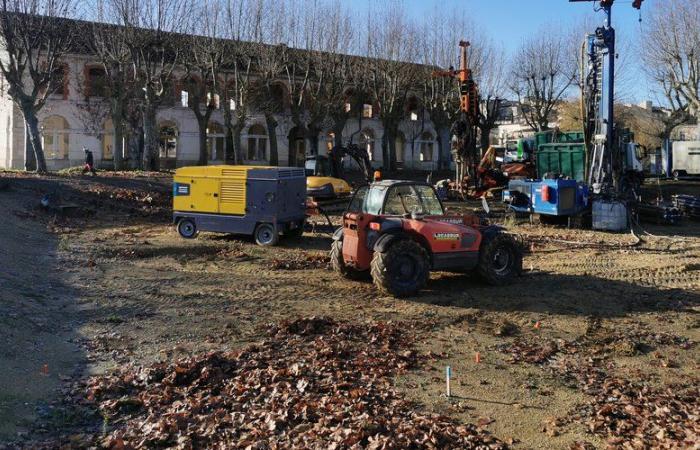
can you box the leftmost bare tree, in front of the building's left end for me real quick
[0,0,79,173]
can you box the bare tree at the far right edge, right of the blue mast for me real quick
[641,0,700,139]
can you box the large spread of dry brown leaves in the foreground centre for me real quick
[88,317,505,449]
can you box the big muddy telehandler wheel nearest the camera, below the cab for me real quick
[371,239,430,297]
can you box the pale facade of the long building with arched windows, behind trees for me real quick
[0,41,450,170]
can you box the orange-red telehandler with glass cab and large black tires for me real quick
[330,180,522,297]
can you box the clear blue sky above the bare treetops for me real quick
[360,0,656,103]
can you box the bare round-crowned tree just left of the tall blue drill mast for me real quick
[510,27,578,131]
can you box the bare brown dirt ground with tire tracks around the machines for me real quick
[0,173,700,449]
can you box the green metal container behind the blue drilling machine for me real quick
[536,143,586,181]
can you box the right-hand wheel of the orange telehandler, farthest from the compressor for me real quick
[477,233,523,286]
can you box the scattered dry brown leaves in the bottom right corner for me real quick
[498,329,700,449]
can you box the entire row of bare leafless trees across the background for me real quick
[0,0,700,171]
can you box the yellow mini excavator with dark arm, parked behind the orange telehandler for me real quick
[305,142,373,213]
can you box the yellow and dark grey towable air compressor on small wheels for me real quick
[173,166,306,245]
